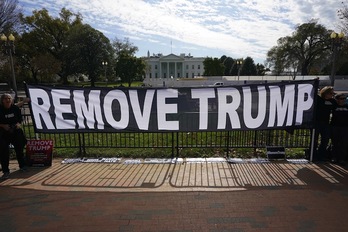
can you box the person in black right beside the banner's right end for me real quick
[314,86,337,161]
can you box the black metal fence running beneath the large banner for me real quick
[22,106,311,157]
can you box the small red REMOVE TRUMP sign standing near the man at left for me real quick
[26,140,53,167]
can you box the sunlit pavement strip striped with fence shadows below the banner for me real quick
[0,161,348,191]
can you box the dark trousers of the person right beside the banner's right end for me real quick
[313,123,331,161]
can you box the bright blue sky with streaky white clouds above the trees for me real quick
[18,0,343,64]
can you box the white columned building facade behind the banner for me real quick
[145,53,205,79]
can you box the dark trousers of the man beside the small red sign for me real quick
[0,129,27,173]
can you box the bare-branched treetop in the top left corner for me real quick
[0,0,21,34]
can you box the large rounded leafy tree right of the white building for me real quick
[267,20,330,75]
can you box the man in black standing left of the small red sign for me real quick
[0,93,26,179]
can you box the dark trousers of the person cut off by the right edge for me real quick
[332,126,348,162]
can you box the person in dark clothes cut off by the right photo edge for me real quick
[331,94,348,165]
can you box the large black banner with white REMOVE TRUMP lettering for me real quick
[27,80,318,132]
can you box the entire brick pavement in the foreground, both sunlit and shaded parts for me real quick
[0,159,348,232]
